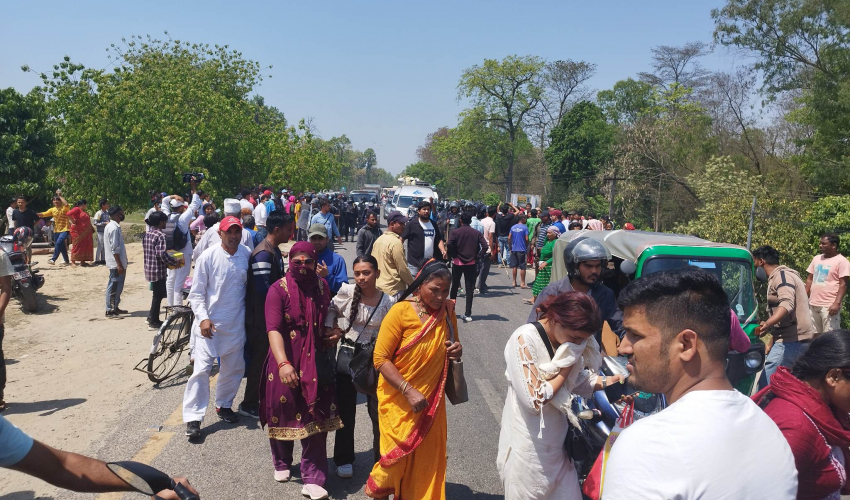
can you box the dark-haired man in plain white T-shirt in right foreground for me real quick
[602,269,797,500]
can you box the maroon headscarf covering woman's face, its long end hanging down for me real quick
[284,241,330,414]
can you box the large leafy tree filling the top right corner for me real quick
[712,0,850,192]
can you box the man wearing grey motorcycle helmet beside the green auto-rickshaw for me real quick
[528,237,625,345]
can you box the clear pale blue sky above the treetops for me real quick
[0,0,736,173]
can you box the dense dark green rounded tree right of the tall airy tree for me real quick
[545,101,614,195]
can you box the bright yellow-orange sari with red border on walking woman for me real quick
[366,301,457,500]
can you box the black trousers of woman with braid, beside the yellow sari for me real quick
[334,374,381,467]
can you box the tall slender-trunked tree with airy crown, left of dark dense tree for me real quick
[458,56,545,197]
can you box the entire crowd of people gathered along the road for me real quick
[0,178,850,500]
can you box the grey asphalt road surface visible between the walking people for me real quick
[58,234,531,500]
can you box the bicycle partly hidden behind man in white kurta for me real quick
[135,306,195,384]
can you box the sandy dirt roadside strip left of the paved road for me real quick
[0,243,162,500]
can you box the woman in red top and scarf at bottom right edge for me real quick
[753,330,850,500]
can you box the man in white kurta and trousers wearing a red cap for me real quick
[183,216,251,439]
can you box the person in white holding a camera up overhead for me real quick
[165,175,201,306]
